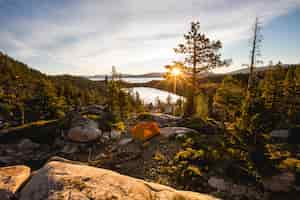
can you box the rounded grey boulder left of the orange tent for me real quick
[67,119,102,142]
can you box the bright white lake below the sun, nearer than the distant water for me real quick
[130,87,182,104]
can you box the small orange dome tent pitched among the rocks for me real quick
[131,122,160,141]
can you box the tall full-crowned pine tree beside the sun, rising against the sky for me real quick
[174,22,224,115]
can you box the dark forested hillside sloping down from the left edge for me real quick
[0,52,104,126]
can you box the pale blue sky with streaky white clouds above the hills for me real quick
[0,0,300,75]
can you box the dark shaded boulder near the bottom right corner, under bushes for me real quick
[262,172,296,192]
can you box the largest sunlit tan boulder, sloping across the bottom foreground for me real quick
[19,161,216,200]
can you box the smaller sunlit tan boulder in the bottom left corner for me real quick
[0,165,30,200]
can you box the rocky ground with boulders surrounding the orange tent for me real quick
[0,106,297,200]
